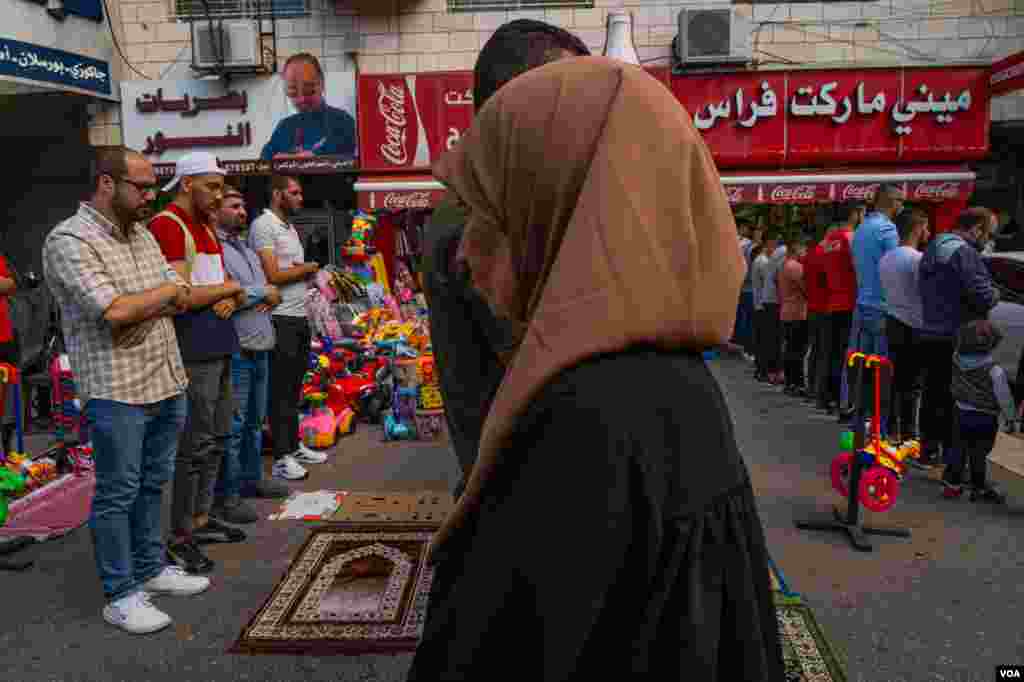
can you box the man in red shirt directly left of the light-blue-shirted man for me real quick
[818,202,867,414]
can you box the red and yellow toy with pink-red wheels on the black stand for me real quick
[831,353,921,512]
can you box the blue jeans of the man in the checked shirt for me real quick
[85,395,187,601]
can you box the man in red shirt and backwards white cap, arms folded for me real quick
[150,152,245,573]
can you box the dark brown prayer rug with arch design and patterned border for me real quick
[228,524,437,655]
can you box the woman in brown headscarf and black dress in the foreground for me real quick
[409,57,783,682]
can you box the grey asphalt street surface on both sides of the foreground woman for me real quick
[0,356,1024,682]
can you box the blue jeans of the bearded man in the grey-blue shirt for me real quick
[215,350,270,502]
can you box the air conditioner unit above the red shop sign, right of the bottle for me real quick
[673,7,753,65]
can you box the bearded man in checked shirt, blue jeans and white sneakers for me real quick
[43,147,210,633]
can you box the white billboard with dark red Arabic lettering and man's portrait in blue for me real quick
[121,73,356,169]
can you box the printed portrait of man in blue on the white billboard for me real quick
[260,52,356,161]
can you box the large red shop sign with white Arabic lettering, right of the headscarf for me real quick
[670,68,989,167]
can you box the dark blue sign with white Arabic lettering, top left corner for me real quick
[0,38,111,95]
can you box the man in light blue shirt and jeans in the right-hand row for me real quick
[840,184,903,421]
